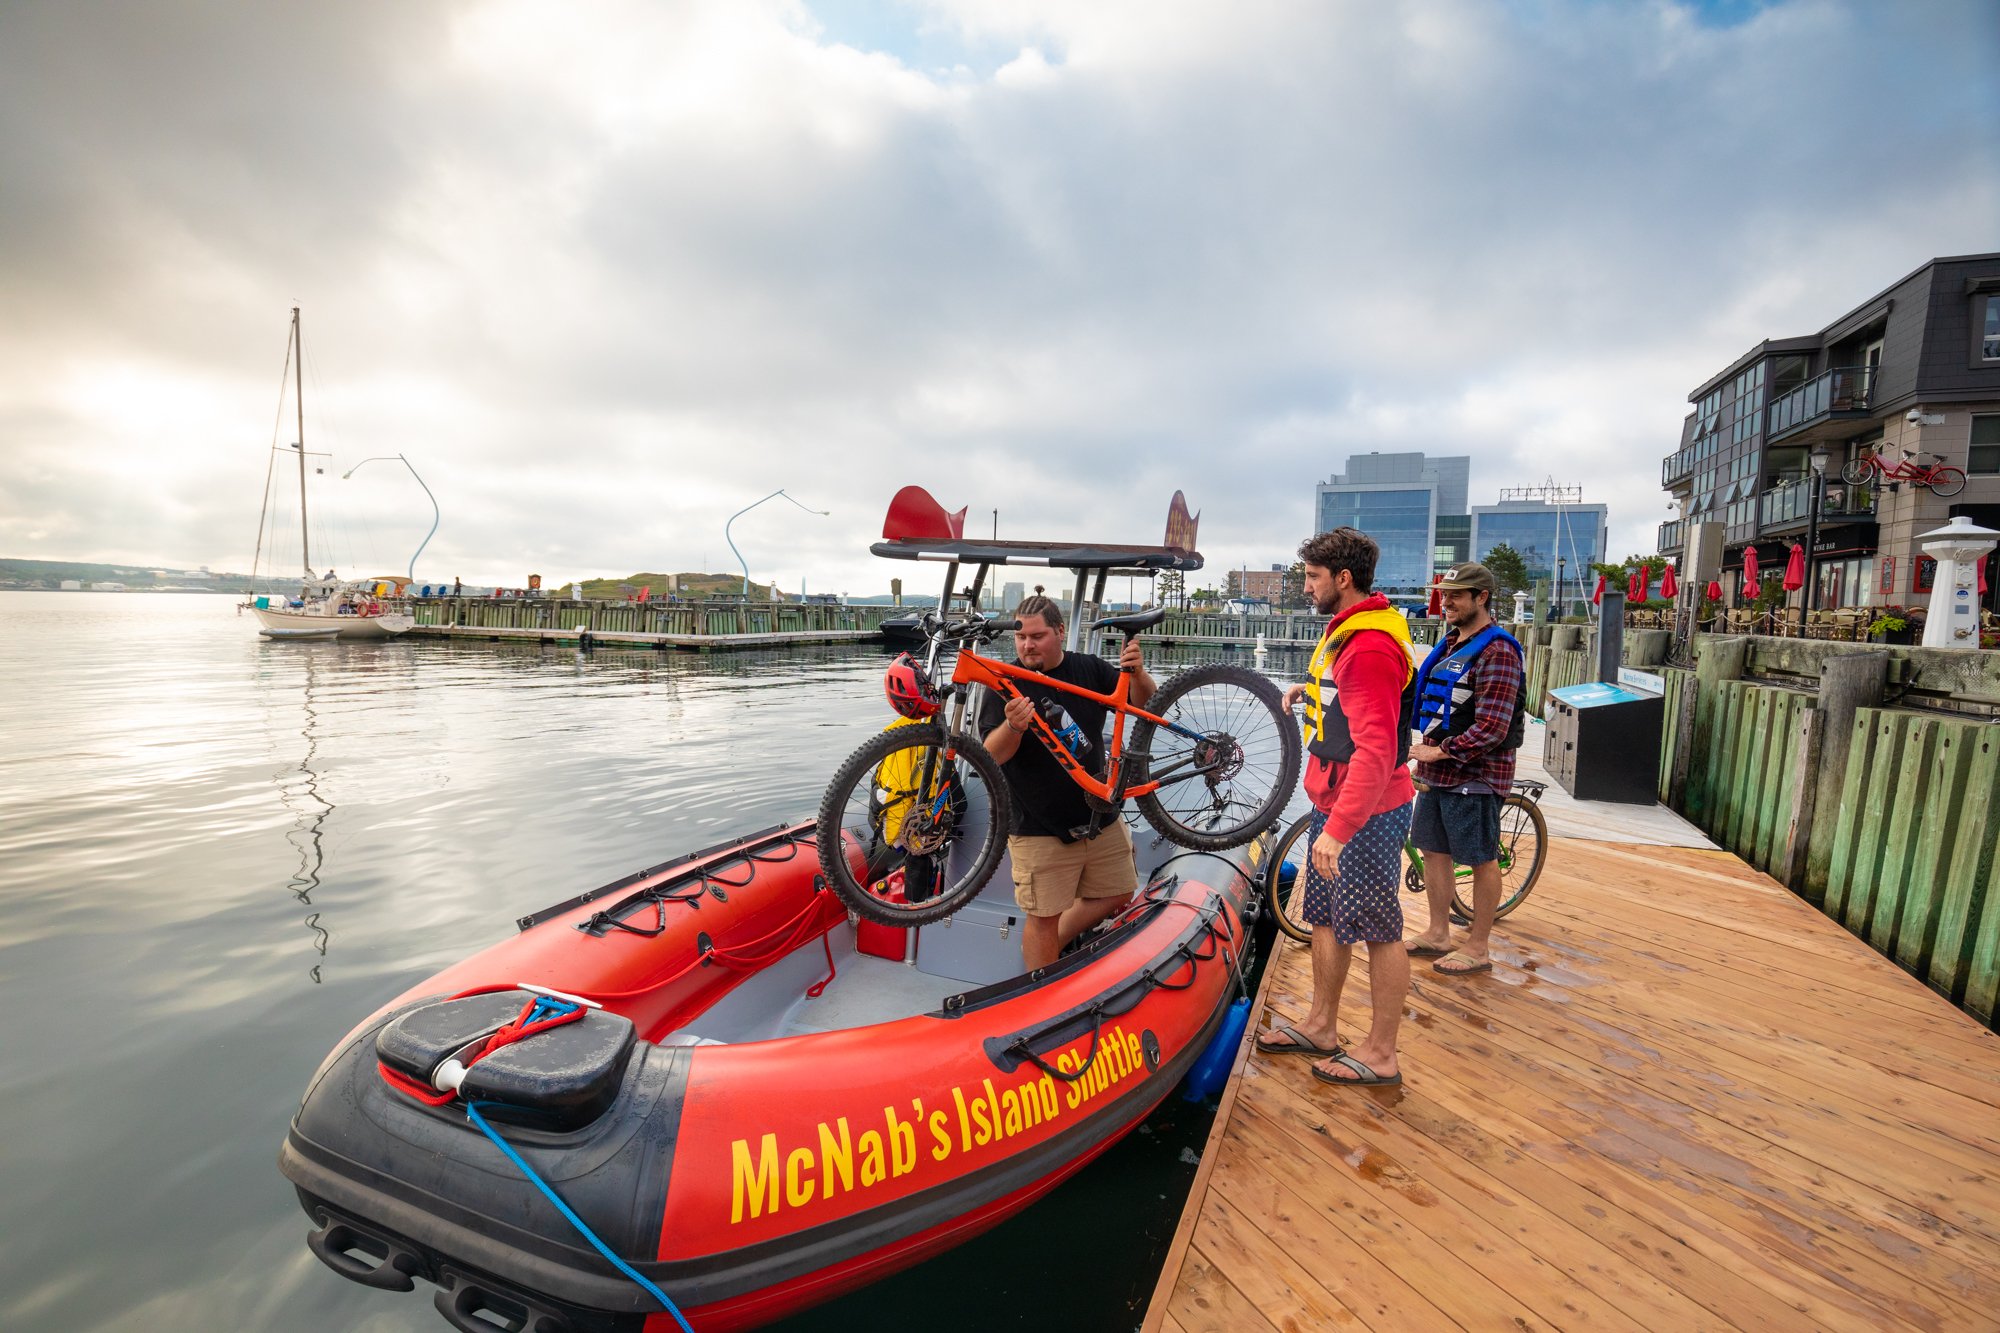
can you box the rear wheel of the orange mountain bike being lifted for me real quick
[1128,662,1300,851]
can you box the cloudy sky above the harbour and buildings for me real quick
[0,0,2000,594]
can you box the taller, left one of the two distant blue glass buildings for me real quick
[1314,452,1472,600]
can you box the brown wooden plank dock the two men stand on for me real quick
[1144,836,2000,1333]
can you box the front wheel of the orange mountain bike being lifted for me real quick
[818,723,1012,927]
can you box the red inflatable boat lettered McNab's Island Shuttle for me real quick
[280,825,1264,1333]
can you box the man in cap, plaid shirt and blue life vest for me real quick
[1408,564,1526,977]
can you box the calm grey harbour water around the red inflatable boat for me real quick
[0,592,1248,1333]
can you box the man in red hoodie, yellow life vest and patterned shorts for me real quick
[1256,528,1416,1087]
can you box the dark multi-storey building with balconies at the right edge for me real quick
[1658,252,2000,608]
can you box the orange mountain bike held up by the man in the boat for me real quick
[818,610,1300,925]
